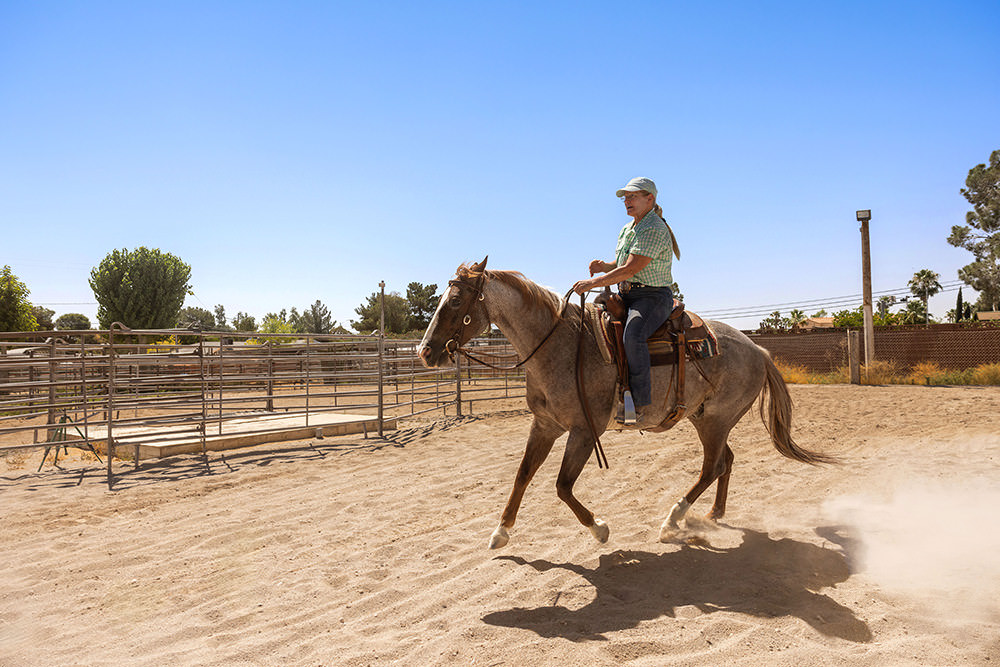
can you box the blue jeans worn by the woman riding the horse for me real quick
[622,287,674,408]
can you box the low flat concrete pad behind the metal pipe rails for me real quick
[88,413,396,459]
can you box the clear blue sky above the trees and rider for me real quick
[0,0,1000,328]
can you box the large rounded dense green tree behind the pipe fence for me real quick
[90,247,191,329]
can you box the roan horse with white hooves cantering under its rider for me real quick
[417,257,835,549]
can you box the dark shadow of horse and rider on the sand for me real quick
[483,527,872,642]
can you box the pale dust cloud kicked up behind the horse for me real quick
[824,470,1000,620]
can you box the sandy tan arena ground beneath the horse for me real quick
[0,386,1000,667]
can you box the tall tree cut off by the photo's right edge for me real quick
[948,150,1000,310]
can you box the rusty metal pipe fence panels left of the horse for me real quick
[0,327,525,488]
